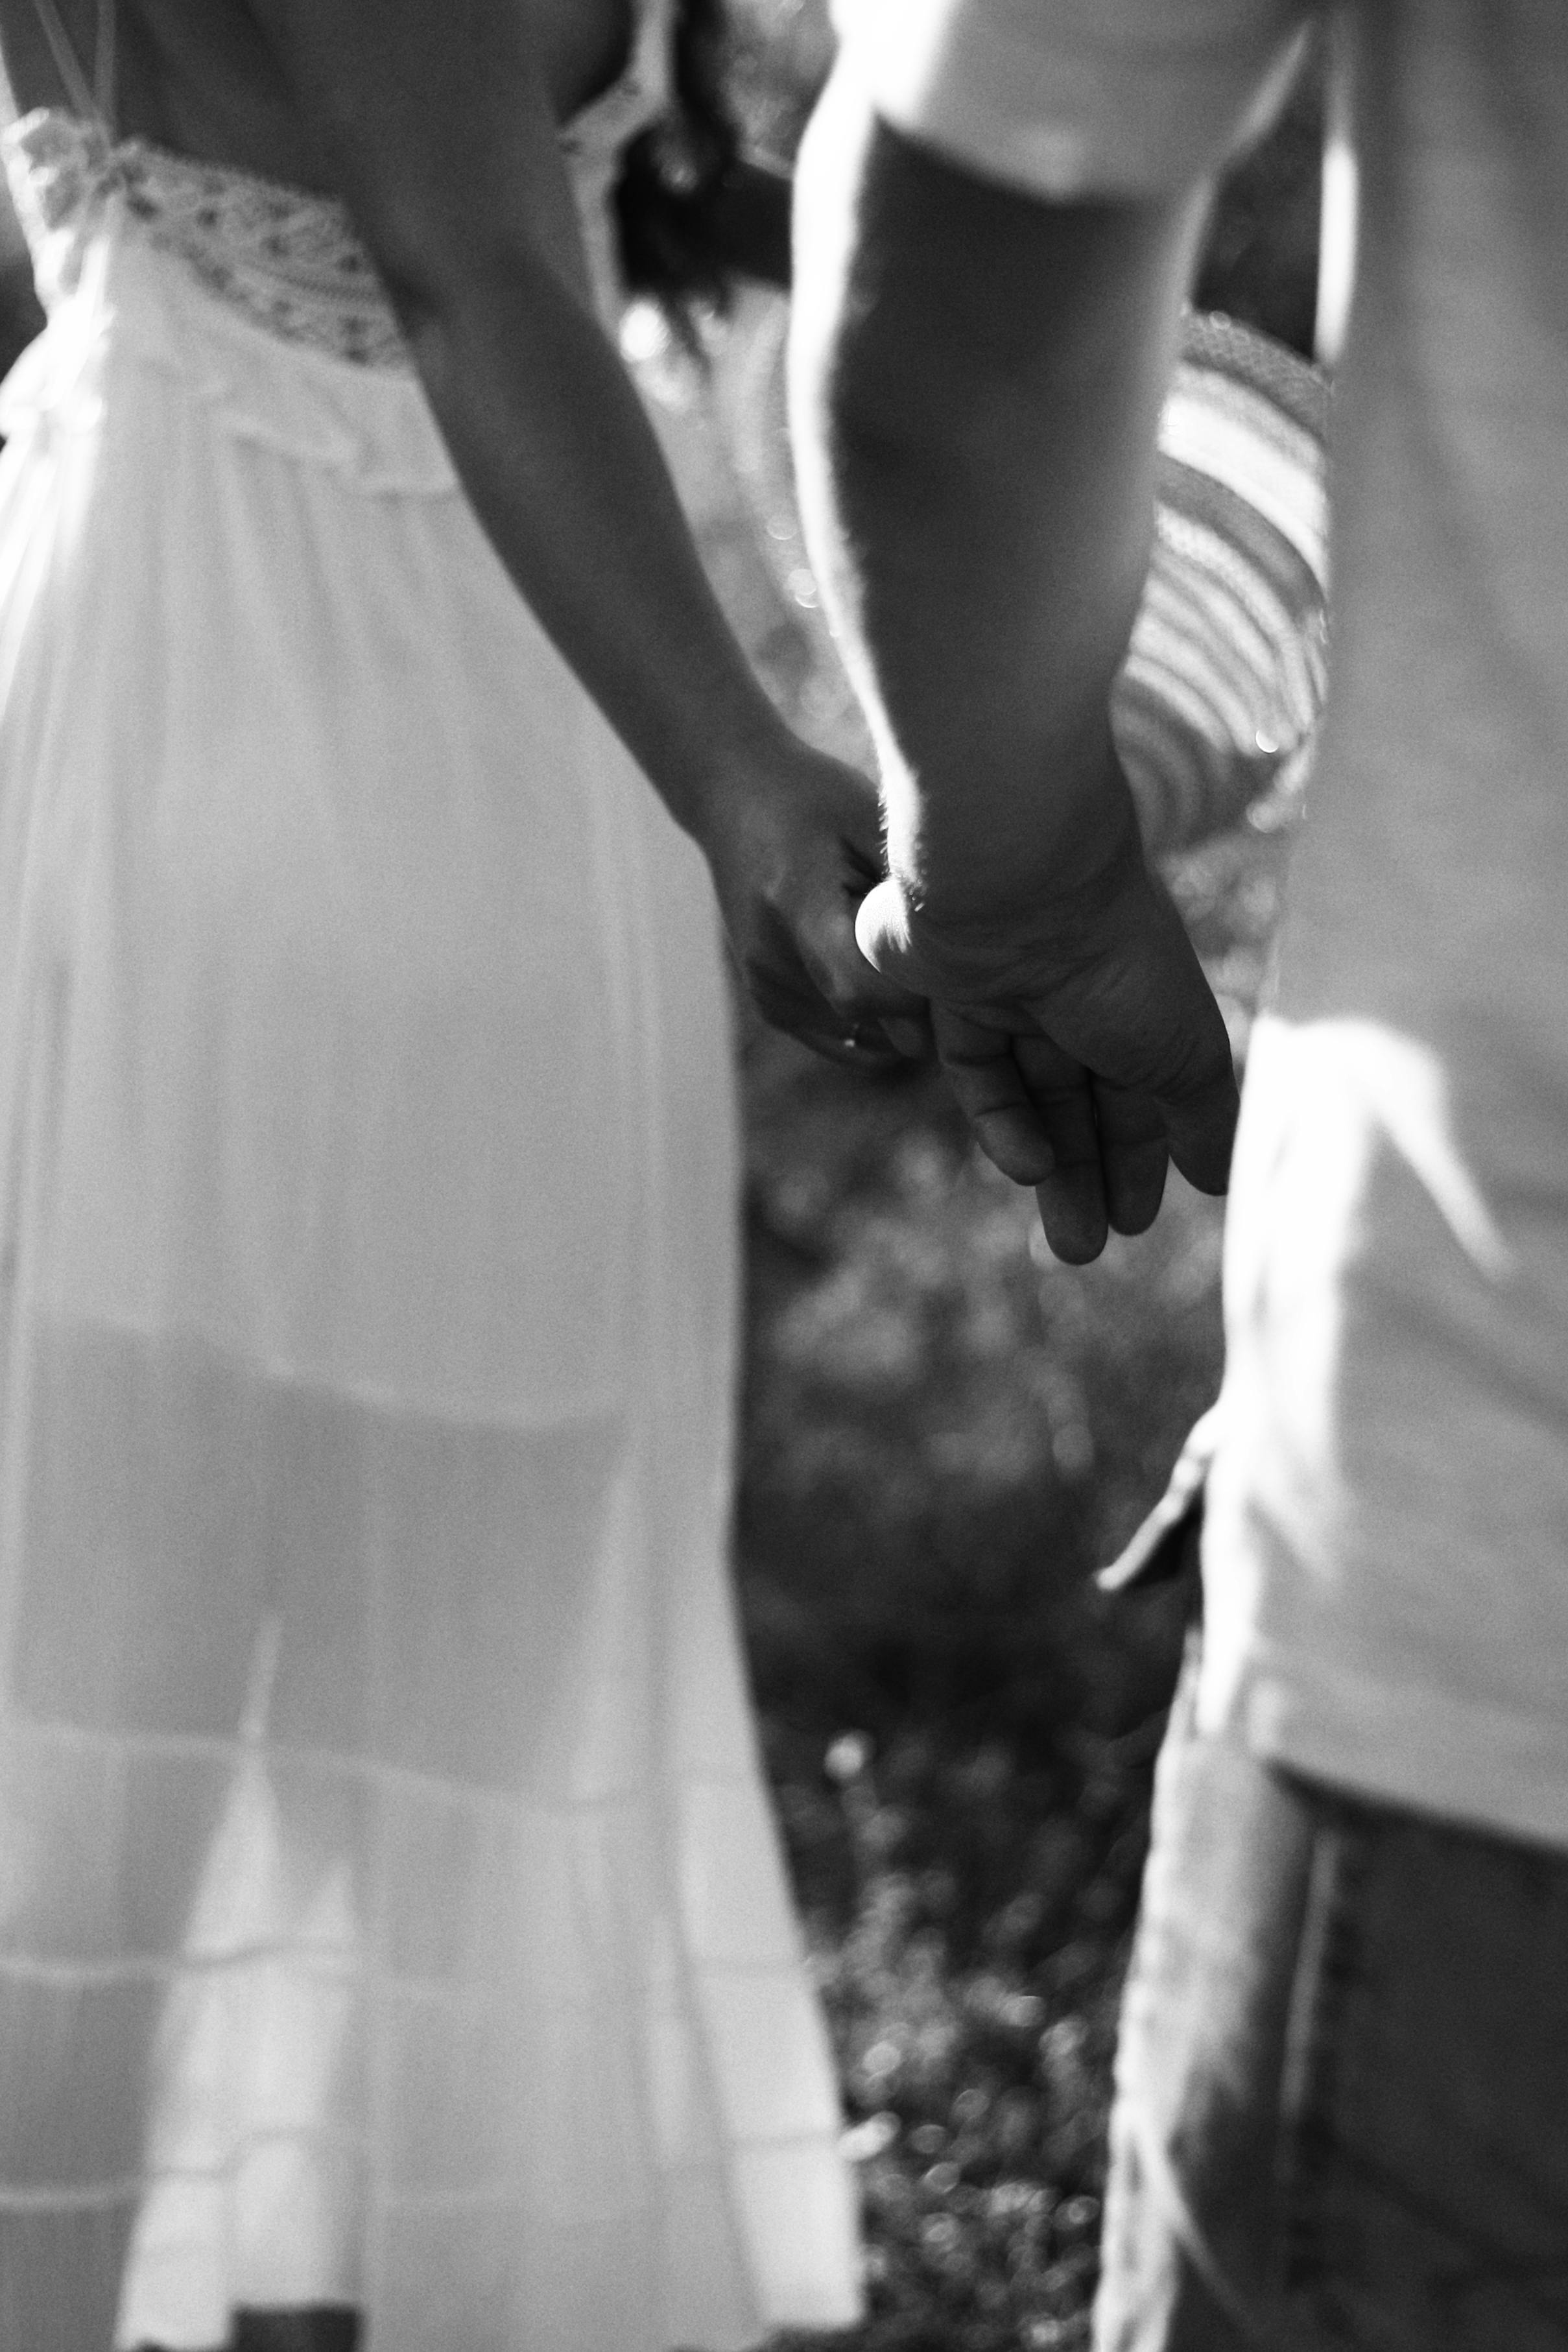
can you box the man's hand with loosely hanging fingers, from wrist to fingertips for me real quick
[858,800,1237,1265]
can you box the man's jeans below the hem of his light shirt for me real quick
[1095,1677,1568,2352]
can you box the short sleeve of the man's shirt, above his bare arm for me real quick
[835,0,1319,198]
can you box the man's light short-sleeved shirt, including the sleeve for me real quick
[839,0,1568,1846]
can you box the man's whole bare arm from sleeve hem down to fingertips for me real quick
[792,68,1237,1258]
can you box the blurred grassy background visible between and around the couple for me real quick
[731,0,1319,2352]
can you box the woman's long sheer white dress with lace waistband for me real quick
[0,5,858,2352]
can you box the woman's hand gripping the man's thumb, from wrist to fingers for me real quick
[693,743,931,1068]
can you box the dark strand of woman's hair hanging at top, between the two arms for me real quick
[616,0,741,339]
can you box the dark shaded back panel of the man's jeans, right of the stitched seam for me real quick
[1276,1800,1568,2352]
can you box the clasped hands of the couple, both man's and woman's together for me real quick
[703,746,1237,1265]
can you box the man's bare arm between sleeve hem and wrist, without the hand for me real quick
[792,64,1201,918]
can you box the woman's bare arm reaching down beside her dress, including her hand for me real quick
[254,0,914,1044]
